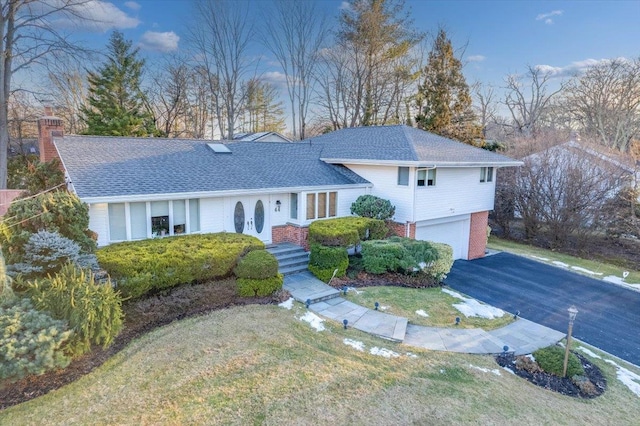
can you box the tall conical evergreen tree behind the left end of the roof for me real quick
[82,31,158,136]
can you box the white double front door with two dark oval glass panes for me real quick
[232,197,271,243]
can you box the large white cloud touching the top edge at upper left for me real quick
[50,0,140,32]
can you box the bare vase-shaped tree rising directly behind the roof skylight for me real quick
[190,0,254,139]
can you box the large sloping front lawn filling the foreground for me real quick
[0,304,640,425]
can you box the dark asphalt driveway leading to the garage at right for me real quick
[445,253,640,365]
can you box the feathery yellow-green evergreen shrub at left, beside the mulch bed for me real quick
[27,263,123,355]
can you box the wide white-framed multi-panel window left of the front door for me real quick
[108,199,200,242]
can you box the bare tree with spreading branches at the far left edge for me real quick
[0,0,92,189]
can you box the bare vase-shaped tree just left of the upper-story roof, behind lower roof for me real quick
[263,0,327,139]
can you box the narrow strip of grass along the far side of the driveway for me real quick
[487,236,640,284]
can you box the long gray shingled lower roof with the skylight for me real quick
[55,136,369,198]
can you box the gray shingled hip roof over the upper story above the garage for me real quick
[309,125,522,167]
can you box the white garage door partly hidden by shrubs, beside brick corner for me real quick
[416,215,471,259]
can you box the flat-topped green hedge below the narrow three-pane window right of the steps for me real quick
[309,216,388,247]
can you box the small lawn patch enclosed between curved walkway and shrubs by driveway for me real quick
[346,287,513,330]
